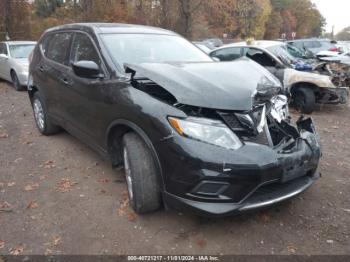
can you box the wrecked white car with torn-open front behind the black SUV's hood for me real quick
[210,41,350,114]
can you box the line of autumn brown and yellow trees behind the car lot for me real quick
[0,0,325,40]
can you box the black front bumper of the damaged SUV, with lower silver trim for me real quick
[158,119,321,216]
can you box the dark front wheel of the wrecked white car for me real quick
[292,87,316,114]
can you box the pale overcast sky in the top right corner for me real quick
[311,0,350,33]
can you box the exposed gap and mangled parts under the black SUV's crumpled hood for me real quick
[131,74,312,150]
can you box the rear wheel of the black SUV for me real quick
[32,92,60,136]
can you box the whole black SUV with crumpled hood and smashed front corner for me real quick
[28,24,321,216]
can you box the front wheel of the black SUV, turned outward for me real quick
[122,133,161,214]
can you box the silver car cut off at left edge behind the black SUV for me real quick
[0,41,36,91]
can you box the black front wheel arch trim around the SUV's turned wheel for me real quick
[106,119,164,188]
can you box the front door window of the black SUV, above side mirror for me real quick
[71,33,101,65]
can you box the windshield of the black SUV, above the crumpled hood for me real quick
[101,34,213,69]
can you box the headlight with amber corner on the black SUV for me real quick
[168,117,242,149]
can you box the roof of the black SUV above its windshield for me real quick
[46,23,177,35]
